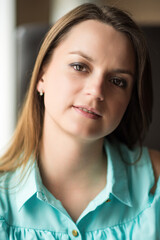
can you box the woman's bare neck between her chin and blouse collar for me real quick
[39,116,106,195]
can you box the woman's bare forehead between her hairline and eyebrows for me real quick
[59,20,132,54]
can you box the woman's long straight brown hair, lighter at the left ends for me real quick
[0,4,152,172]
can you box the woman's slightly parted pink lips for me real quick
[73,106,102,120]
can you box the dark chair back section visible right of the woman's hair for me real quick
[142,26,160,150]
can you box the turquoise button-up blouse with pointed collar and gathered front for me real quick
[0,141,160,240]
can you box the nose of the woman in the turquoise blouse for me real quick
[85,76,104,101]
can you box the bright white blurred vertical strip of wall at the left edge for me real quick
[0,0,16,154]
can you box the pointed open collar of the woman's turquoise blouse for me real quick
[16,140,132,211]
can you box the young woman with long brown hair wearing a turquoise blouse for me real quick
[0,4,160,240]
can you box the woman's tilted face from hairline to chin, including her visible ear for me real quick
[37,20,135,141]
